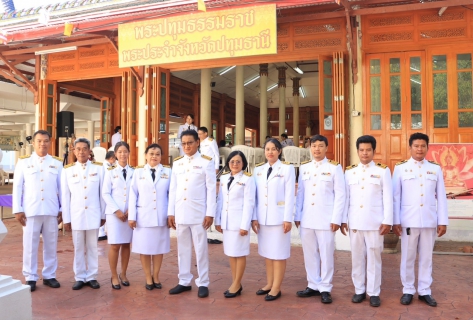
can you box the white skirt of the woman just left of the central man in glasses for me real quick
[131,227,171,255]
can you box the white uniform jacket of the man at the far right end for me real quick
[393,158,448,228]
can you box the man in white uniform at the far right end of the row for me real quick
[393,133,448,307]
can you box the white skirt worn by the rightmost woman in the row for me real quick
[258,224,291,260]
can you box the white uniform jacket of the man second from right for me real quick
[343,161,393,230]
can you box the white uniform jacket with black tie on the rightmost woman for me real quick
[253,160,295,226]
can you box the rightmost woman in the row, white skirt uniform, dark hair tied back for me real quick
[252,138,296,301]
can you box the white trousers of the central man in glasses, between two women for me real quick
[176,224,210,287]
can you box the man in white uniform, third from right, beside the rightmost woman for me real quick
[294,135,345,303]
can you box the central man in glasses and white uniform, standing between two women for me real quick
[168,130,216,298]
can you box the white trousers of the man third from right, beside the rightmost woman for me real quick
[300,227,335,292]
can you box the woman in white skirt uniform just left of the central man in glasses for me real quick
[128,143,171,290]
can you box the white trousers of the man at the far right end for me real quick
[401,228,437,296]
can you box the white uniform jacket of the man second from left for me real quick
[61,161,105,230]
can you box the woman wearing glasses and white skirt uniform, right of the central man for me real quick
[215,151,256,298]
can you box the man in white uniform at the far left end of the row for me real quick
[13,130,62,292]
